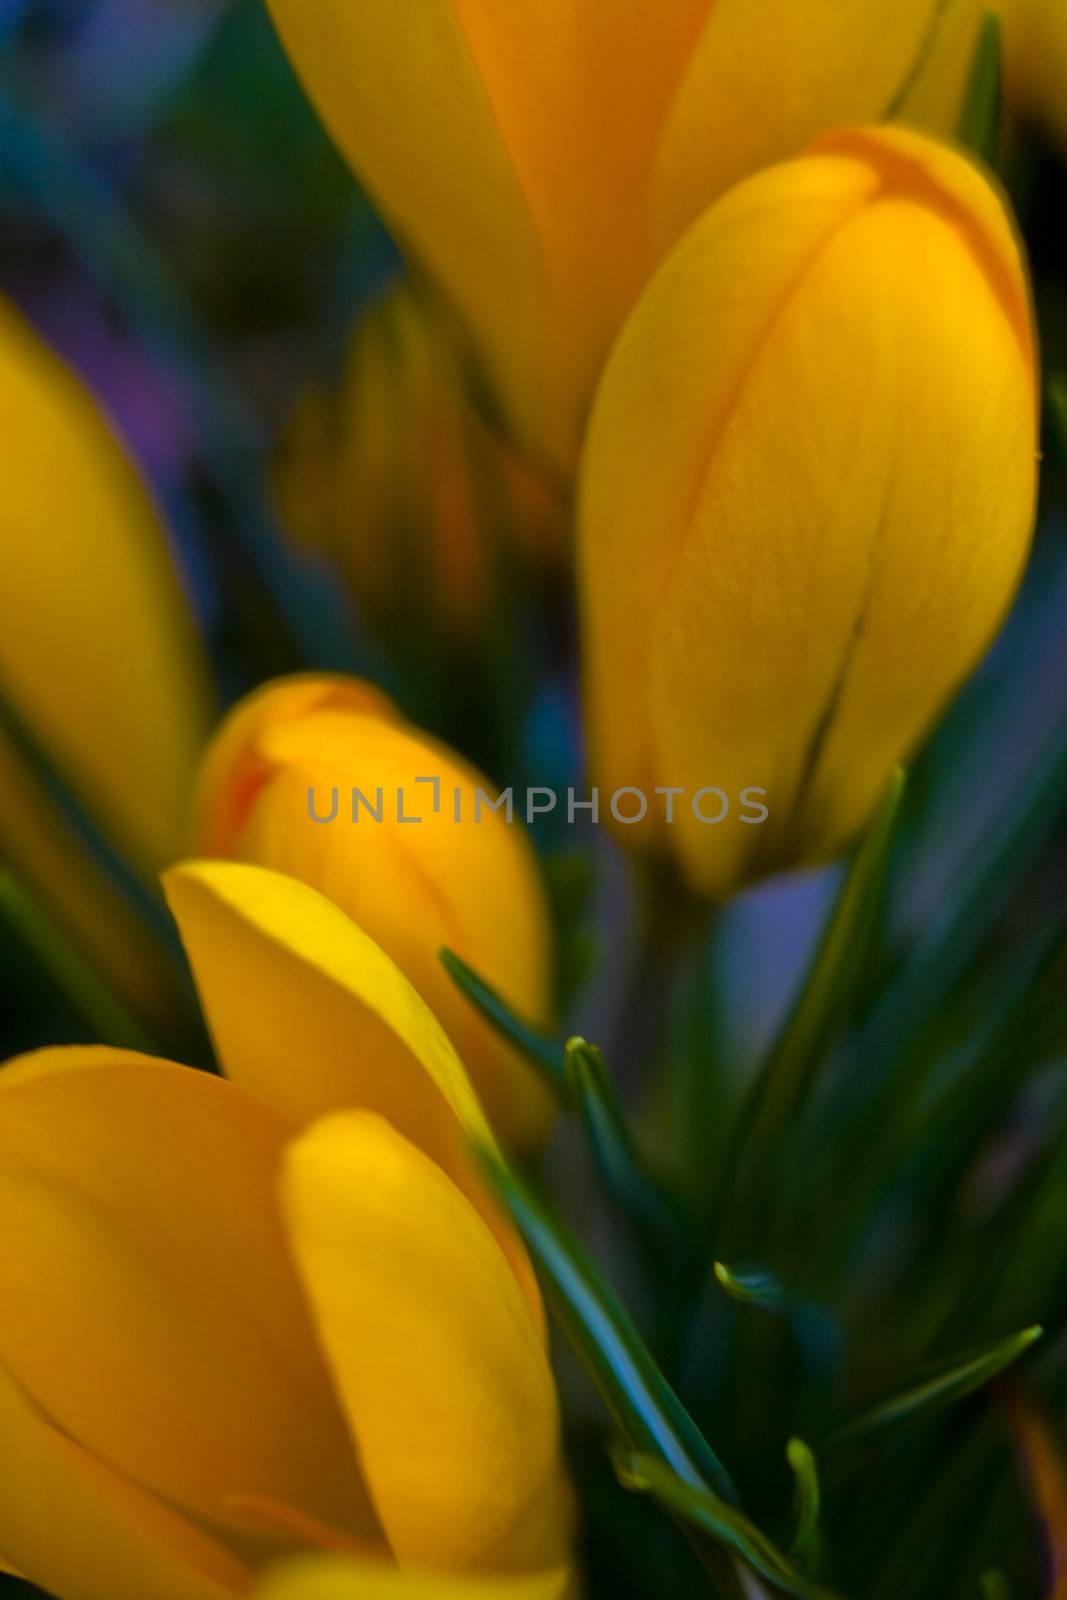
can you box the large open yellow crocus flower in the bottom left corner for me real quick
[0,862,568,1600]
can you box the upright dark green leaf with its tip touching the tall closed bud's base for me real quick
[720,768,904,1246]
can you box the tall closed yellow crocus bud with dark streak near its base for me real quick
[579,128,1037,896]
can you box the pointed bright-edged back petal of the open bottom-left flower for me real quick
[165,862,541,1307]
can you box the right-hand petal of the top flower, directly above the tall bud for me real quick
[649,0,979,254]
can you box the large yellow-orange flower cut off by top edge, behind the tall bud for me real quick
[267,0,979,469]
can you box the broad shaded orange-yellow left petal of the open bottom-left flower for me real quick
[0,1050,373,1542]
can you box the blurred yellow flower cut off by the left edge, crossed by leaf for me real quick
[0,299,210,987]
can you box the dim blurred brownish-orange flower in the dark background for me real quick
[275,282,563,642]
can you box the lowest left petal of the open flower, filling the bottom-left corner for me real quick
[0,1347,248,1600]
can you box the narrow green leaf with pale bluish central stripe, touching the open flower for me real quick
[475,1149,736,1501]
